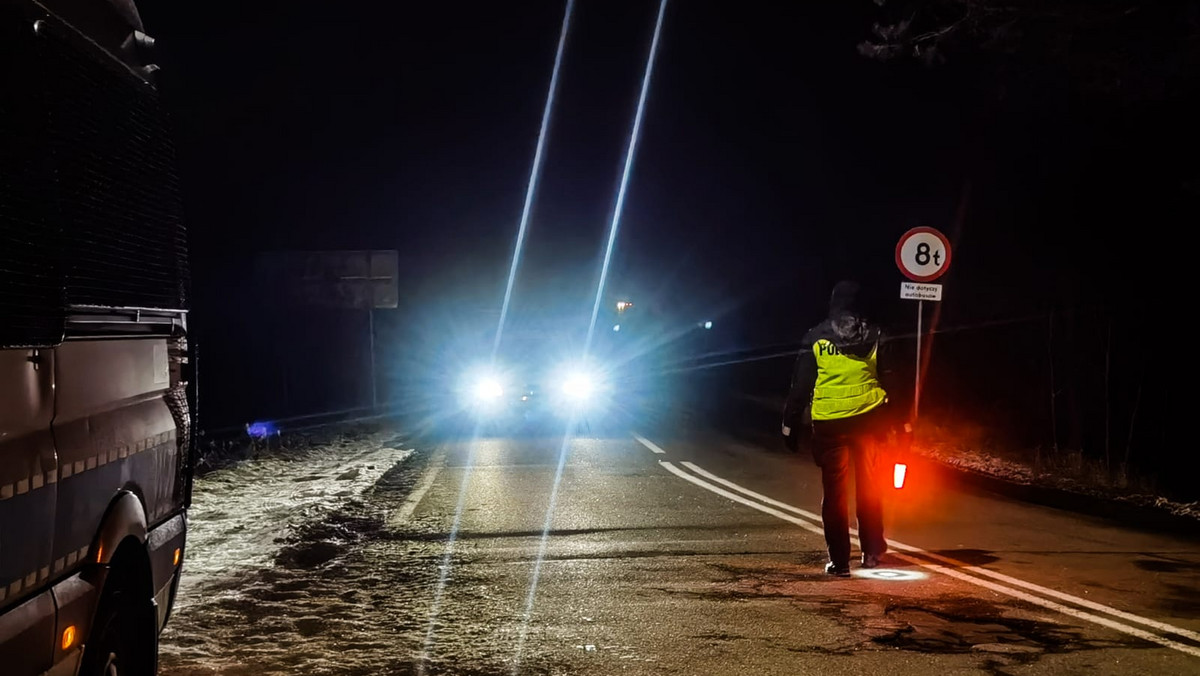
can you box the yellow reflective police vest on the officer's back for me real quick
[812,339,888,420]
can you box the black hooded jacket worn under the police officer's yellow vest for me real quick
[784,282,895,436]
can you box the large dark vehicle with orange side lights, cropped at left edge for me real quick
[0,0,194,676]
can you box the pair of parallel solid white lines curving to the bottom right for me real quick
[659,451,1200,657]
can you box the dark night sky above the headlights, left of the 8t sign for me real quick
[143,1,984,333]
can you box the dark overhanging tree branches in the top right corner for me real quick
[858,0,1200,102]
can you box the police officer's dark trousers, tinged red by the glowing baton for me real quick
[812,409,888,566]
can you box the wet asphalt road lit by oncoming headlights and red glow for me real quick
[162,421,1200,676]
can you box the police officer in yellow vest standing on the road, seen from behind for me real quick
[784,281,892,576]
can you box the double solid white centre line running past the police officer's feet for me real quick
[652,437,1200,657]
